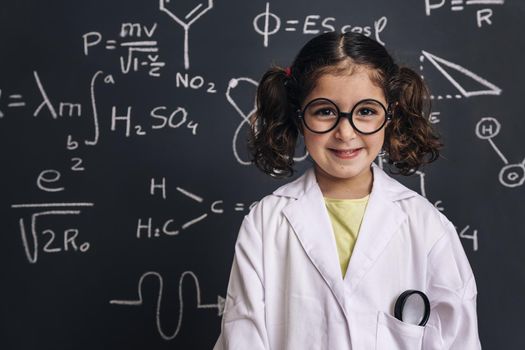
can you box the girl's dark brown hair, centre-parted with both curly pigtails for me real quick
[248,32,443,177]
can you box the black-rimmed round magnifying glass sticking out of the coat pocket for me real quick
[394,289,430,326]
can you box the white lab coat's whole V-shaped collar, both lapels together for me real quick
[274,163,416,319]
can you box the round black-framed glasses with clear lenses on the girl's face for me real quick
[297,97,392,135]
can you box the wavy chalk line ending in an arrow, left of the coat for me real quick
[109,271,225,340]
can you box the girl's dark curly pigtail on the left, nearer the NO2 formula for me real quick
[248,67,299,178]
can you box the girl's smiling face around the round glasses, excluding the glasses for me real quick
[301,67,387,189]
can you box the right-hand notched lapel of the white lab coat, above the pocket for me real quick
[345,163,415,296]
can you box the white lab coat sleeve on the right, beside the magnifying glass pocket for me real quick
[423,214,481,350]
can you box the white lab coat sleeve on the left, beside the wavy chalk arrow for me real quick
[214,213,269,350]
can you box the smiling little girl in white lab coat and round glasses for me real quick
[215,32,481,350]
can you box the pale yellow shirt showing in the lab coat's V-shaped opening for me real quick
[324,195,370,277]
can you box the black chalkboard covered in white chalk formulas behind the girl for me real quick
[0,0,525,350]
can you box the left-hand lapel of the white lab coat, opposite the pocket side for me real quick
[284,169,345,311]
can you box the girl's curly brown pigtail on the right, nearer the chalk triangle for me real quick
[384,67,443,175]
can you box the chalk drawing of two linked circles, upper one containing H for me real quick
[476,117,525,188]
